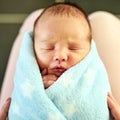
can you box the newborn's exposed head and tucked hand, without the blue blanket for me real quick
[34,4,91,88]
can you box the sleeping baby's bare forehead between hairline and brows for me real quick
[34,16,89,38]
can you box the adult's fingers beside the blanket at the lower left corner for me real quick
[0,98,11,120]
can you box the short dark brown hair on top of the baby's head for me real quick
[34,3,92,40]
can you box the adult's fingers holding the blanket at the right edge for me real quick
[107,93,120,120]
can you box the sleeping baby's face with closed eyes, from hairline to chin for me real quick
[34,16,90,76]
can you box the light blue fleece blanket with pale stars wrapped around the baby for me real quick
[9,32,110,120]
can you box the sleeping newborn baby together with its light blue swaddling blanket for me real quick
[9,3,110,120]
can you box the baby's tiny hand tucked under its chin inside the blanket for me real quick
[42,68,58,89]
